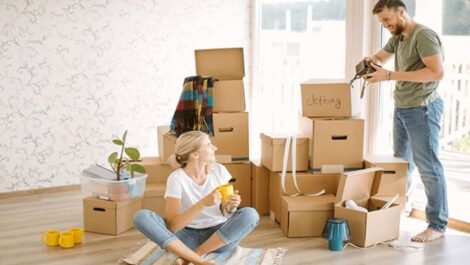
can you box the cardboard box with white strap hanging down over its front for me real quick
[260,133,309,172]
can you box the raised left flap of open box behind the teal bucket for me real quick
[336,167,383,204]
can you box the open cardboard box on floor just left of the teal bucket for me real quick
[281,194,335,237]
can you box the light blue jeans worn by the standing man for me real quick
[393,98,449,232]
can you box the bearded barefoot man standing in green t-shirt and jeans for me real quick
[364,0,448,242]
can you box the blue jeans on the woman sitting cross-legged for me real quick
[134,207,259,253]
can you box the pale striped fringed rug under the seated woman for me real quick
[119,242,287,265]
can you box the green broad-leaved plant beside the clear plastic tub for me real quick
[108,130,145,181]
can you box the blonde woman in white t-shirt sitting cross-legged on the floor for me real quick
[134,131,259,265]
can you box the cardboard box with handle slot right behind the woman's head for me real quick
[211,112,250,161]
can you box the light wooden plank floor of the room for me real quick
[0,191,470,265]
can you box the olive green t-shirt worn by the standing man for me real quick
[383,24,444,108]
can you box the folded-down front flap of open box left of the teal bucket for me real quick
[282,194,335,211]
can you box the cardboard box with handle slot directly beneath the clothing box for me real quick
[299,117,364,170]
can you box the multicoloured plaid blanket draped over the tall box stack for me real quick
[170,76,214,137]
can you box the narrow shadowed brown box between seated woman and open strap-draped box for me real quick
[251,161,270,215]
